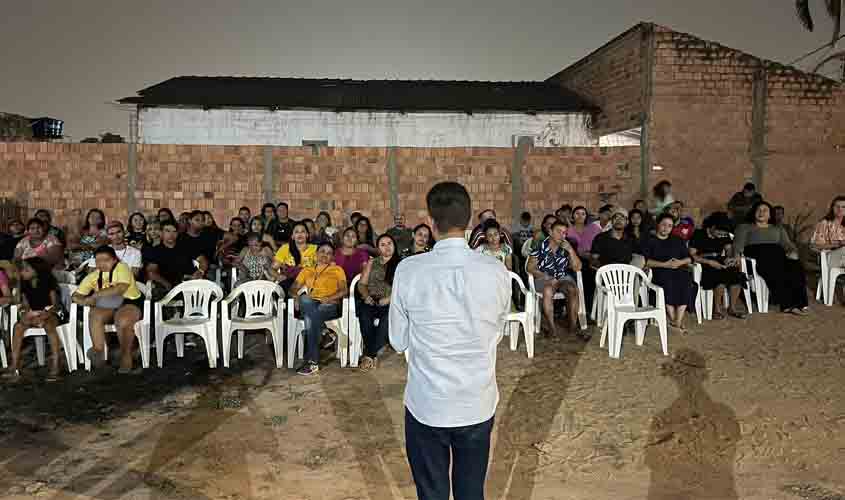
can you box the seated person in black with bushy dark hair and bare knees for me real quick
[689,212,747,319]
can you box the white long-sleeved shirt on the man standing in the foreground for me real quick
[390,238,511,427]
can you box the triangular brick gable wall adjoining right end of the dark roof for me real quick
[549,24,646,135]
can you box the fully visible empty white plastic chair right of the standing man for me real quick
[596,264,669,359]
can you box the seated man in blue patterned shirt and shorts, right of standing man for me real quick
[528,220,584,337]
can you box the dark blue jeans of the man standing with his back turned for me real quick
[405,408,493,500]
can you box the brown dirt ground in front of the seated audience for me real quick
[0,305,845,500]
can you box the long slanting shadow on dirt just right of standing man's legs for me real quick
[487,335,586,500]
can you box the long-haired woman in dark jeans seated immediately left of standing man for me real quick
[358,234,399,372]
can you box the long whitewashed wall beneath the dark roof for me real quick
[138,108,598,148]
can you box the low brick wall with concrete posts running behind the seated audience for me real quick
[0,143,639,233]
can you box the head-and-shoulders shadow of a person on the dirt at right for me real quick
[645,349,740,500]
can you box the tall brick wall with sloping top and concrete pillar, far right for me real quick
[649,26,845,216]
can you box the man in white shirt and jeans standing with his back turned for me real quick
[390,182,511,500]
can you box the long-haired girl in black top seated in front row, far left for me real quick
[4,256,67,382]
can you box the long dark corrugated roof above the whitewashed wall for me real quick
[119,76,598,113]
